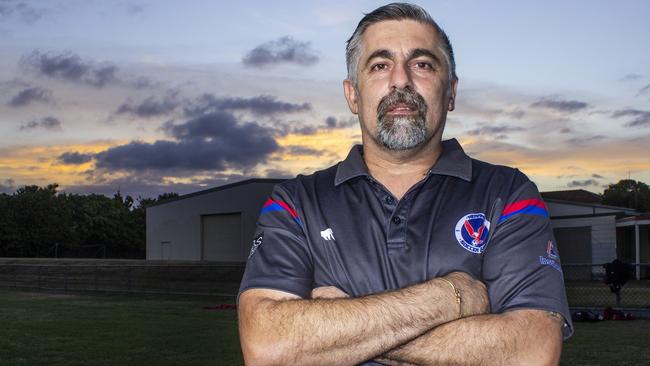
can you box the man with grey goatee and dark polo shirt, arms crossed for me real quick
[238,4,571,365]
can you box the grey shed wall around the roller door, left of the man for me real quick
[147,182,275,261]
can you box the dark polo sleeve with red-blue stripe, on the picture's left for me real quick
[239,185,313,298]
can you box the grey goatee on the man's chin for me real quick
[377,116,427,151]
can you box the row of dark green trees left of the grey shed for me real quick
[0,184,178,258]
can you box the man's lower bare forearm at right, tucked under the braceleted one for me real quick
[378,310,563,365]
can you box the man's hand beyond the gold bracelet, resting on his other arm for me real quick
[443,272,490,317]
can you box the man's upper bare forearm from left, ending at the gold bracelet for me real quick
[240,282,455,365]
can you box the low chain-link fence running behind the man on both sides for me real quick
[0,260,650,309]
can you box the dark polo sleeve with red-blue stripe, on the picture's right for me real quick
[483,173,573,339]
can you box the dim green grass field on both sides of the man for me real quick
[0,290,650,366]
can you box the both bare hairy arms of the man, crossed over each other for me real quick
[239,272,562,365]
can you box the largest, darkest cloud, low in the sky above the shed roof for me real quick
[95,112,280,172]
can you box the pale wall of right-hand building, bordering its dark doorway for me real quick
[551,216,616,264]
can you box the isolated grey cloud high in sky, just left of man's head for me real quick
[242,36,319,67]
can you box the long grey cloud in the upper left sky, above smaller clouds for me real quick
[20,50,119,88]
